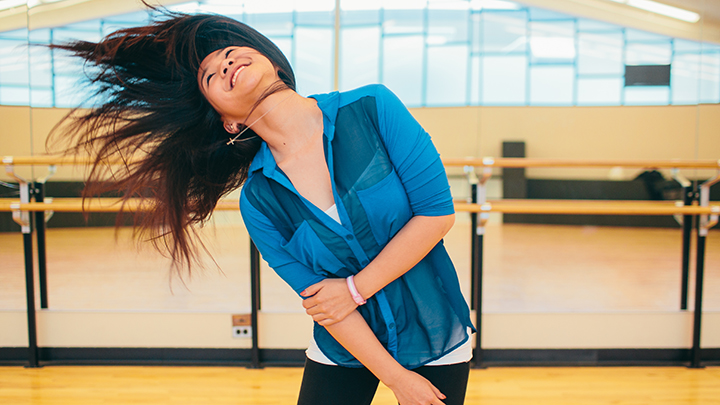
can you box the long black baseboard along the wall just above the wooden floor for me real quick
[0,347,720,367]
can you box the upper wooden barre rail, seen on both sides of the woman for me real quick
[3,156,720,169]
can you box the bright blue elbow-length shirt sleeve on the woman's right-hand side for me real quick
[376,85,455,216]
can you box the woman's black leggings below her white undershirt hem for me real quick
[298,359,470,405]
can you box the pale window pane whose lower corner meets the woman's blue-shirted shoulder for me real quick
[382,35,424,106]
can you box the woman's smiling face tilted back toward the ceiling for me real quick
[198,46,279,133]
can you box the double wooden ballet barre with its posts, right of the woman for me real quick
[443,157,720,367]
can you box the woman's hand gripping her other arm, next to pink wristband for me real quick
[300,278,357,326]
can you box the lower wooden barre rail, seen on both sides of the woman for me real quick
[0,198,720,215]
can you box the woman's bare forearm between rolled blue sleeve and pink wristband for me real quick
[354,214,455,299]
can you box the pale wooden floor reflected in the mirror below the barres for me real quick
[0,220,720,313]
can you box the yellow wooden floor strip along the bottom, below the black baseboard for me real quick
[0,366,720,405]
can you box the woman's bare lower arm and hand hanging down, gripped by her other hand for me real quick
[326,311,445,405]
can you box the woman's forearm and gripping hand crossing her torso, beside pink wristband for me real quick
[301,214,455,327]
